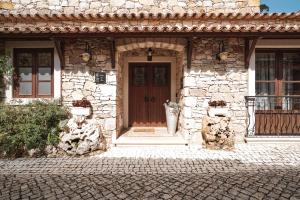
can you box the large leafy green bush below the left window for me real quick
[0,102,68,157]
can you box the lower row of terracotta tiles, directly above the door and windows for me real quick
[0,25,300,33]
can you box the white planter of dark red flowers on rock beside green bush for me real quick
[71,98,92,117]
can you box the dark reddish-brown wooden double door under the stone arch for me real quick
[129,63,171,127]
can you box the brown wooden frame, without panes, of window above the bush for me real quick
[13,48,54,98]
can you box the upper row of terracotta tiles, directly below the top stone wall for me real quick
[0,12,300,21]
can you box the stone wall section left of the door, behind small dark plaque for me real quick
[62,39,117,144]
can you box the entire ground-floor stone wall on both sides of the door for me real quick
[62,38,248,142]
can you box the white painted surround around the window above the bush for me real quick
[5,41,61,103]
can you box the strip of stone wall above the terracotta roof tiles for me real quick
[0,0,260,14]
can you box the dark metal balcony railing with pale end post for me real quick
[245,96,300,136]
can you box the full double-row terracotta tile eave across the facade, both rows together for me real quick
[0,13,300,34]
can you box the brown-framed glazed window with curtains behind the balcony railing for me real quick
[255,49,300,109]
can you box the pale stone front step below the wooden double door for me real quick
[113,136,188,147]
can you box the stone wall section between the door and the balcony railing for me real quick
[181,38,248,141]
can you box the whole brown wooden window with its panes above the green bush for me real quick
[13,48,54,98]
